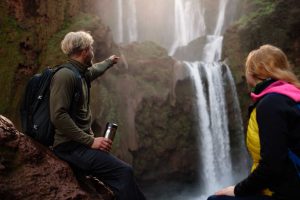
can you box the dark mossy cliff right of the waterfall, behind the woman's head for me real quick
[223,0,300,124]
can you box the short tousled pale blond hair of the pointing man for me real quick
[61,31,94,56]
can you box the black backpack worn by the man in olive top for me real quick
[20,64,82,147]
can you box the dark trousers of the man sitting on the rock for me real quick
[54,142,145,200]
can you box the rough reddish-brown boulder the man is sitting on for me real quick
[0,115,113,200]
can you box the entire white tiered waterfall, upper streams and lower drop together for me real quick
[101,0,244,200]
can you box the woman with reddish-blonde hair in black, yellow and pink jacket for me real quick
[208,45,300,200]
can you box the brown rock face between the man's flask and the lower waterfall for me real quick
[91,42,198,184]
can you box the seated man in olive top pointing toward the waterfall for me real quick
[50,31,145,200]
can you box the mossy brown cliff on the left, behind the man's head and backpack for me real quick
[0,0,116,127]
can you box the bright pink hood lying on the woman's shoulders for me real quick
[251,80,300,102]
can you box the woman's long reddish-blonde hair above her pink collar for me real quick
[246,44,300,88]
